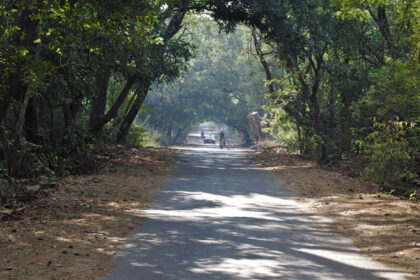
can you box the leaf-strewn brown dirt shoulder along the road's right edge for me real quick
[251,151,420,279]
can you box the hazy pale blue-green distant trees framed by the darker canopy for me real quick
[143,15,265,143]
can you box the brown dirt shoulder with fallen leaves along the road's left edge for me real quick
[0,147,176,280]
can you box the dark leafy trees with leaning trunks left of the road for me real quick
[0,0,191,177]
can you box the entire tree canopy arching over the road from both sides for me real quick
[0,0,420,188]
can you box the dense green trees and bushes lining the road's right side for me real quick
[202,0,420,188]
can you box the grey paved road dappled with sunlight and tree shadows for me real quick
[105,149,404,280]
